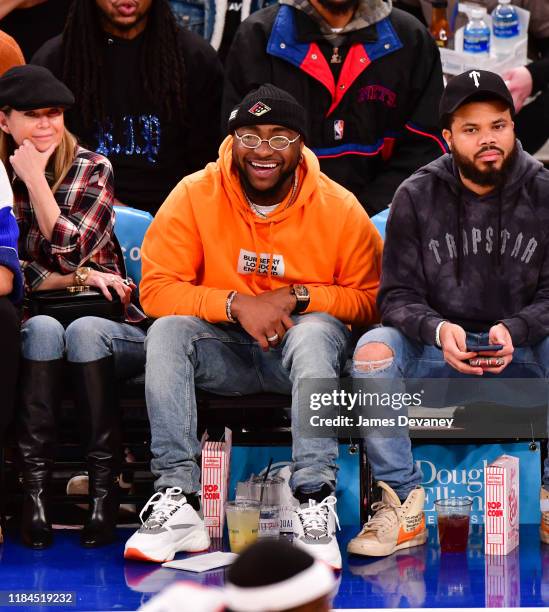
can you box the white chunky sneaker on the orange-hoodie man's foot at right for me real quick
[293,495,341,570]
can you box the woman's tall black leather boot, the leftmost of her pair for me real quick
[17,359,64,549]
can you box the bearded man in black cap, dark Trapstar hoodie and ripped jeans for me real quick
[348,70,549,556]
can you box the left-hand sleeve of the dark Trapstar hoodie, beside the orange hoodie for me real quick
[377,187,444,345]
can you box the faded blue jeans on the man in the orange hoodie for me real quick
[145,313,344,493]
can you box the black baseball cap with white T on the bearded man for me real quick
[439,70,515,124]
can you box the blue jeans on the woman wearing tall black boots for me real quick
[21,315,145,379]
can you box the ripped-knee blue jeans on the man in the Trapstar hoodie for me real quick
[352,327,549,500]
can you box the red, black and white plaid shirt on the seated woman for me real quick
[13,147,121,291]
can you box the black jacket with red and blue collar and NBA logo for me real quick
[223,5,446,215]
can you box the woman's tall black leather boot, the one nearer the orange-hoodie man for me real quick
[71,357,122,548]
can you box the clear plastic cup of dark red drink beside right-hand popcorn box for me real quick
[435,497,473,552]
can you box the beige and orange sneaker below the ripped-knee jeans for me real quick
[347,481,427,557]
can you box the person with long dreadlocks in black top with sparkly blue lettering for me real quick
[32,0,223,214]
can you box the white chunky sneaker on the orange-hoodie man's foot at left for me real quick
[124,487,210,563]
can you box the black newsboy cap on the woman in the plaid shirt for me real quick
[0,64,74,111]
